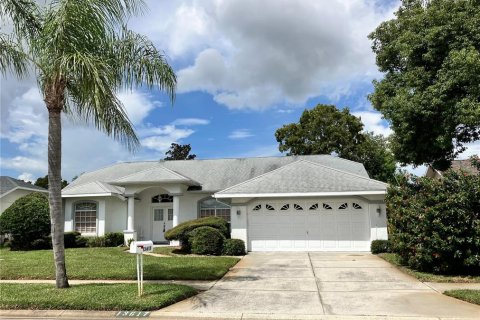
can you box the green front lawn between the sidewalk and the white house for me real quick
[0,248,239,280]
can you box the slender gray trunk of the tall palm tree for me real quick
[46,96,69,288]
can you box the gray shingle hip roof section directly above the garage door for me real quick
[215,160,387,196]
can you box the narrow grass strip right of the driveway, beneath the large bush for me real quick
[378,253,480,283]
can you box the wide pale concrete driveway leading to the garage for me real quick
[159,252,480,319]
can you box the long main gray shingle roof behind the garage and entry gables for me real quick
[63,155,368,194]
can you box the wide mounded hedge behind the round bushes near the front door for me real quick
[165,217,230,252]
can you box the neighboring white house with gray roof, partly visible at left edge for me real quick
[0,176,48,214]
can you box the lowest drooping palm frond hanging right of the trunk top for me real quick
[58,53,140,151]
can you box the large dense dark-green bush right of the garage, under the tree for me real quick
[386,166,480,275]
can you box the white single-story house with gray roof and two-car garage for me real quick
[62,155,387,251]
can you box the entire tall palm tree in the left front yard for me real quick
[0,0,176,288]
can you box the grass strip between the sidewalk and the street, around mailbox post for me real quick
[0,284,197,311]
